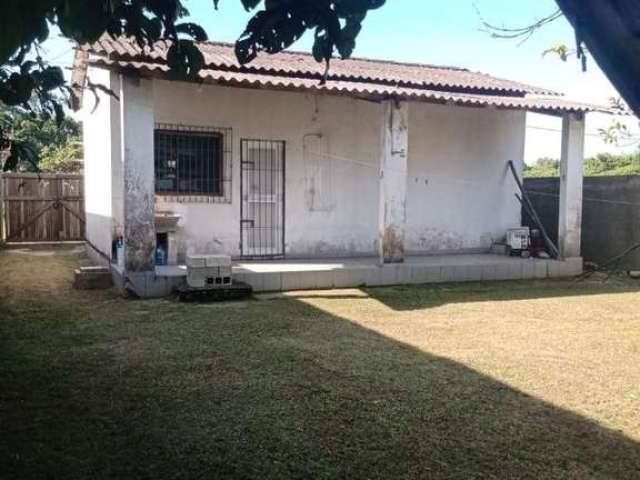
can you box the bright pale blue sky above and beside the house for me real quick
[42,0,638,163]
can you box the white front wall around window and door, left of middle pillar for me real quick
[154,81,380,256]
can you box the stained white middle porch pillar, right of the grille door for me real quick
[378,100,409,264]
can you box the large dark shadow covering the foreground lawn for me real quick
[0,253,640,479]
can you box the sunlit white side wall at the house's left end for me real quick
[81,67,122,256]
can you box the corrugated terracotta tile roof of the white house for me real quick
[81,37,611,113]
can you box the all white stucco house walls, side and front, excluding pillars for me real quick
[85,68,525,257]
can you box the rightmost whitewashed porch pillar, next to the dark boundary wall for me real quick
[558,114,585,258]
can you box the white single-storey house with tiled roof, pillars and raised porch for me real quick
[74,37,597,296]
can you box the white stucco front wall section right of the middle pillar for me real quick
[405,103,525,252]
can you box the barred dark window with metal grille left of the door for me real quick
[154,124,233,203]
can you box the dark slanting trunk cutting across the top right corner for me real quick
[556,0,640,116]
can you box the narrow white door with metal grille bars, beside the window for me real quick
[240,140,285,258]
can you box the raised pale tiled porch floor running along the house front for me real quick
[155,253,582,294]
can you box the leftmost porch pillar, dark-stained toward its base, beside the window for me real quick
[118,75,156,273]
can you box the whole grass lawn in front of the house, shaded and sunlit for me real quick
[0,246,640,479]
